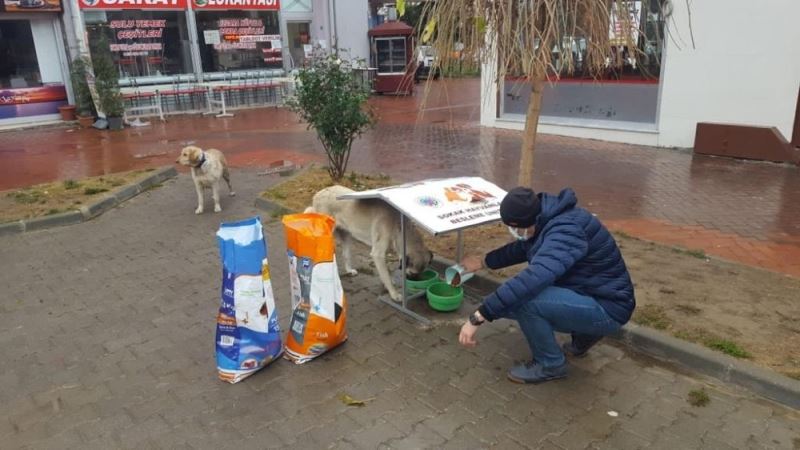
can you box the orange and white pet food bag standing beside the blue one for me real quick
[283,213,347,364]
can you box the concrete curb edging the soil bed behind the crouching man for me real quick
[432,256,800,409]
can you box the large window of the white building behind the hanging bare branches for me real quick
[498,1,664,131]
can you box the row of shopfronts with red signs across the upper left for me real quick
[0,0,369,126]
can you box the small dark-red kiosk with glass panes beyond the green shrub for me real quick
[367,21,415,95]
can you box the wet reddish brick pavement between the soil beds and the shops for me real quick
[0,79,800,276]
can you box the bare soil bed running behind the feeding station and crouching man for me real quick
[262,169,800,379]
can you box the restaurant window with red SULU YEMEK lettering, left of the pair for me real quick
[84,10,192,79]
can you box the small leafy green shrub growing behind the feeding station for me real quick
[287,54,375,181]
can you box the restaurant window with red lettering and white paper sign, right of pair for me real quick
[196,11,283,72]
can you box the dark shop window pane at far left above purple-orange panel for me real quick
[0,20,42,89]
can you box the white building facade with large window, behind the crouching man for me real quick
[481,0,800,147]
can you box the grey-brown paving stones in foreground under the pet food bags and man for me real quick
[0,170,800,450]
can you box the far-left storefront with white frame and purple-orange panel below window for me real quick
[0,0,69,126]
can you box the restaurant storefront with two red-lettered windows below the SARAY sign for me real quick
[79,0,284,87]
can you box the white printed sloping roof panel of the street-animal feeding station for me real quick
[340,177,506,234]
